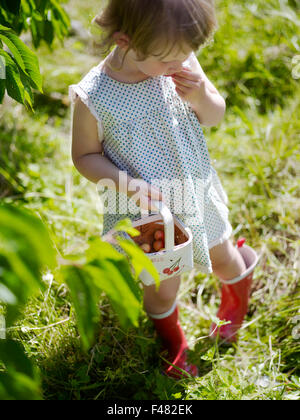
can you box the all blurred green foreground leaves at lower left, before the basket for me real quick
[0,204,159,399]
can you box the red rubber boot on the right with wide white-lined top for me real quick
[210,238,260,343]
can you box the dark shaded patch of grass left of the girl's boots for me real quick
[39,311,204,400]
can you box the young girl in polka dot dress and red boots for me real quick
[70,0,258,378]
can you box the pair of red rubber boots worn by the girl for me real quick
[148,238,259,379]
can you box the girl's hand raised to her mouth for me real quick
[172,67,206,108]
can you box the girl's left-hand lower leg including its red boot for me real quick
[143,276,198,379]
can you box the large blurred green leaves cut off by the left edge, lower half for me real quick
[0,204,55,399]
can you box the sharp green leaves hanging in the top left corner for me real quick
[0,0,70,108]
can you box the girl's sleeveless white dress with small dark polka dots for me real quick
[70,62,232,273]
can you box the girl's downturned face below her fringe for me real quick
[128,46,193,77]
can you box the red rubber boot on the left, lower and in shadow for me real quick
[148,301,198,379]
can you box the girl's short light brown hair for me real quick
[93,0,218,68]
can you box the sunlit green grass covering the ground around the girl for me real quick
[0,0,300,400]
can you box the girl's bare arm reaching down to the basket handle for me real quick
[72,99,133,191]
